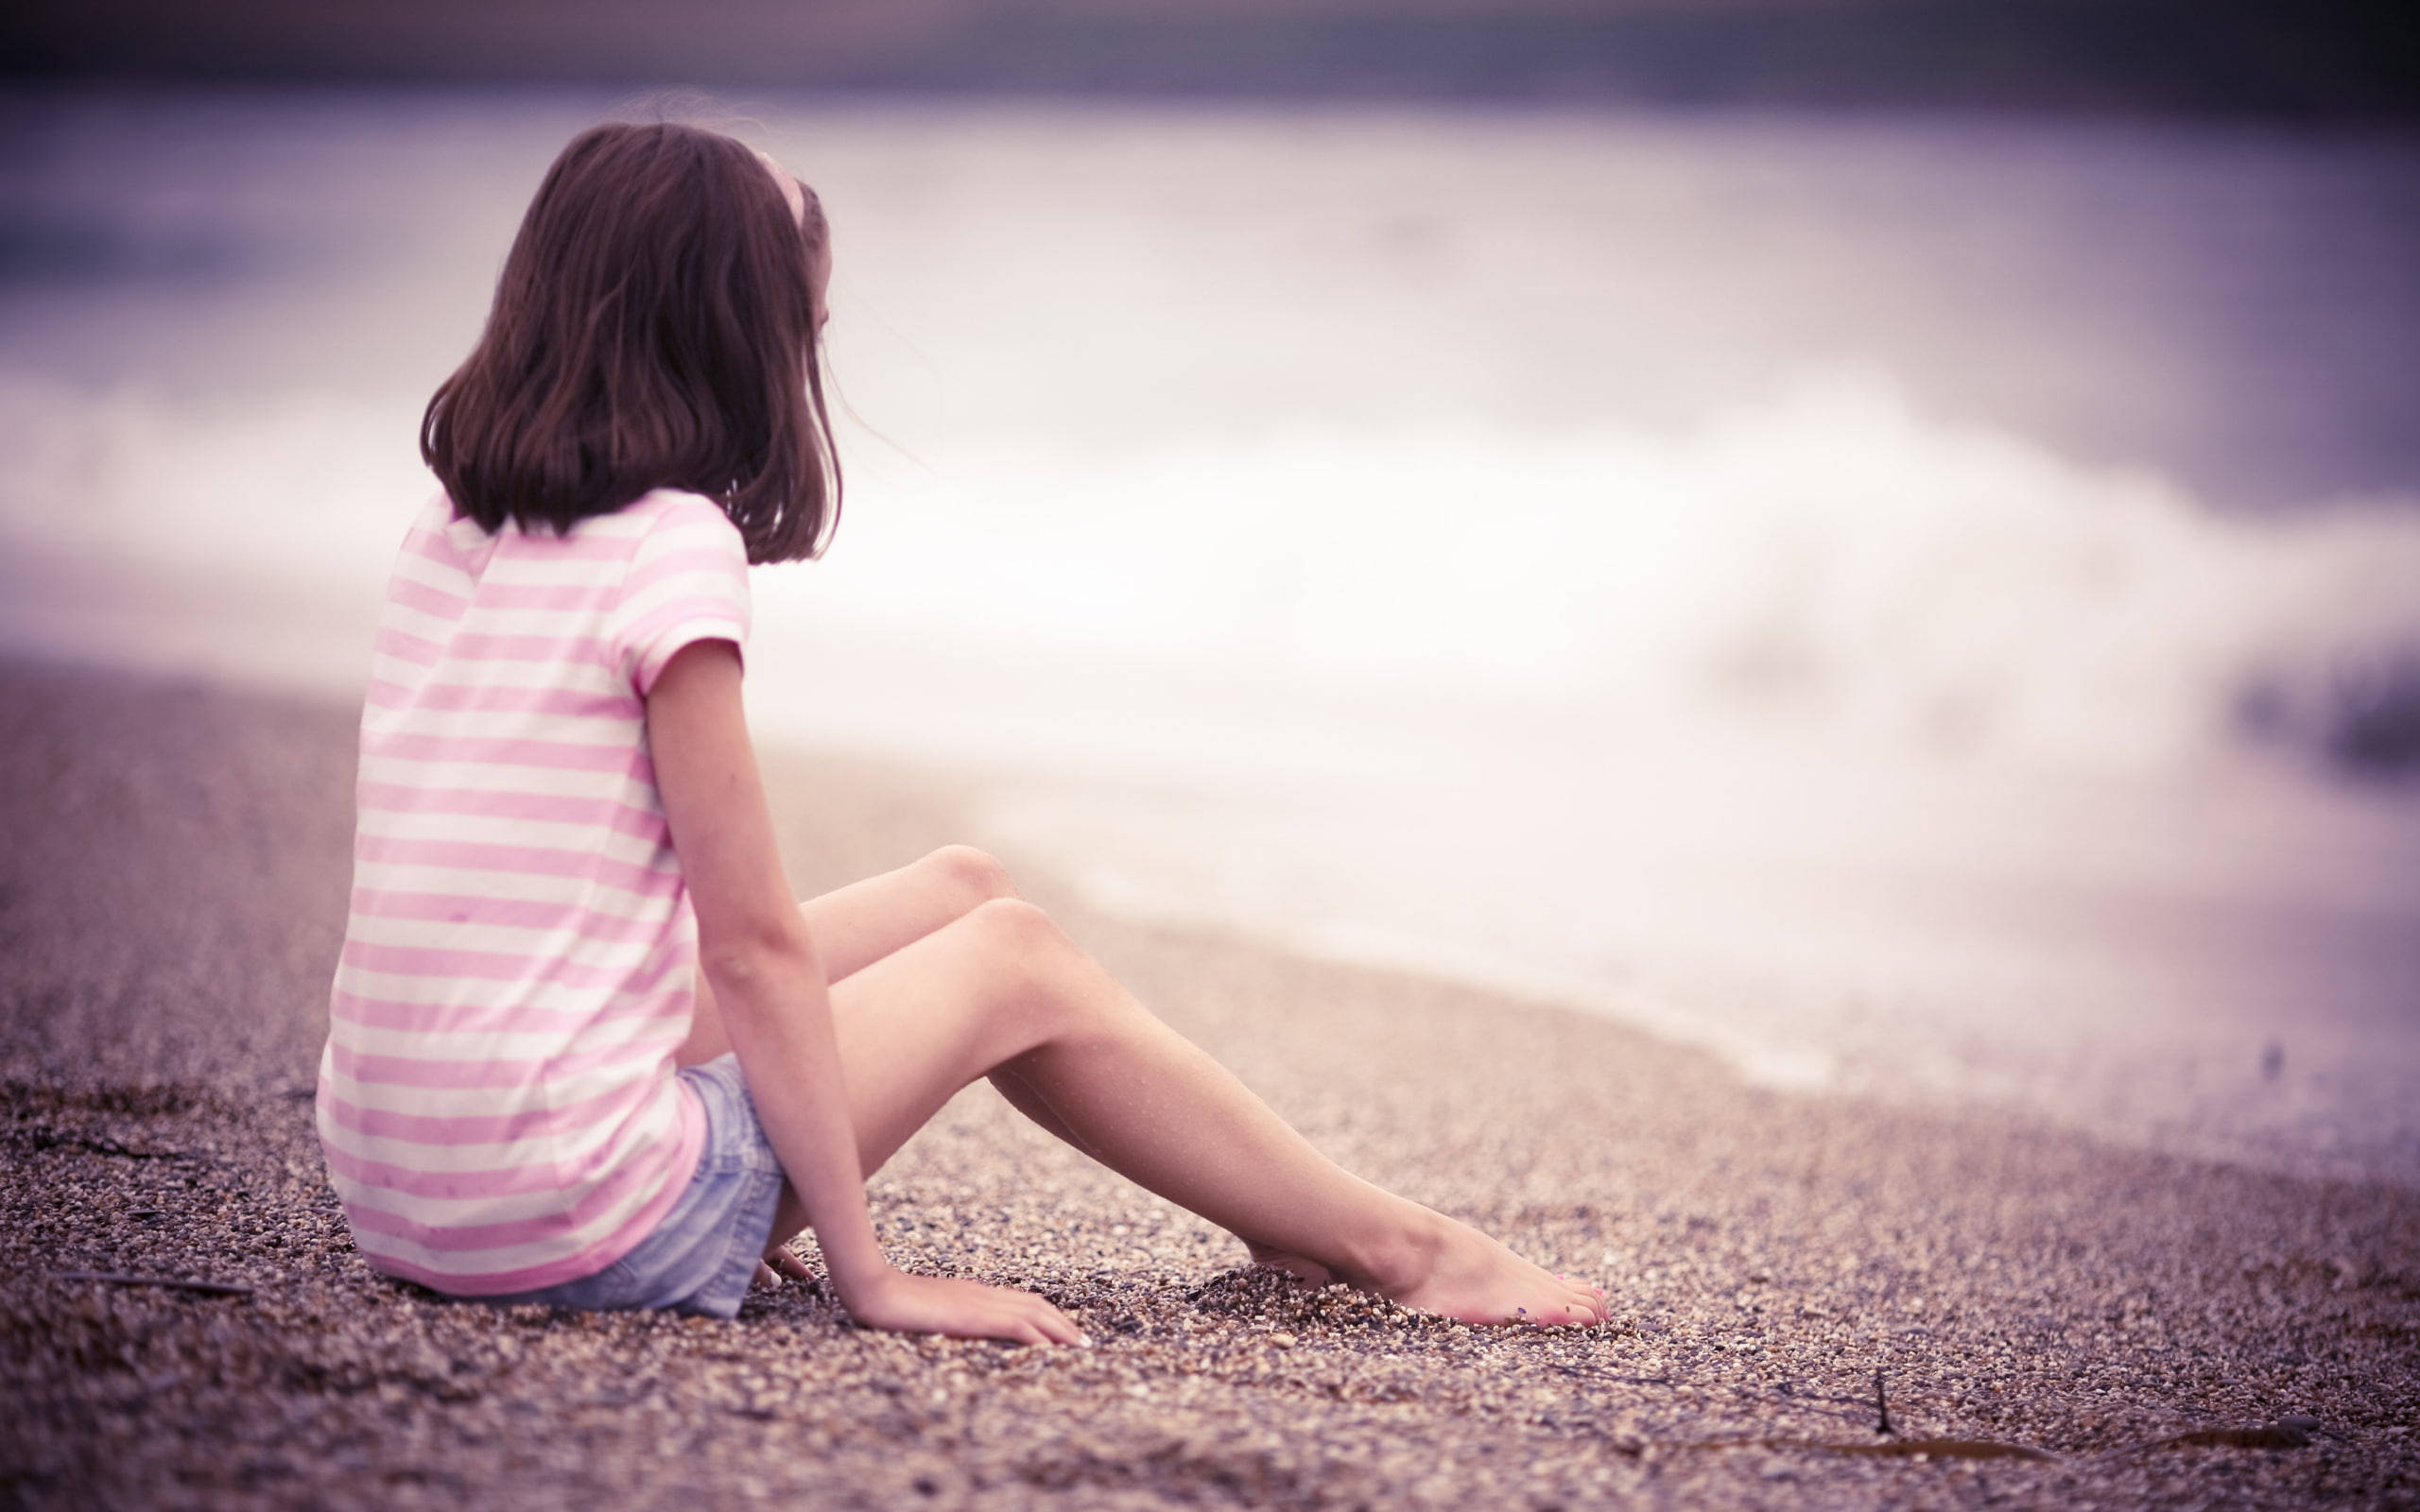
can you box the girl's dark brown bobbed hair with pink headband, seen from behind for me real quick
[421,124,839,561]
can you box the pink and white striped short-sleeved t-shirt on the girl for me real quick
[320,491,748,1297]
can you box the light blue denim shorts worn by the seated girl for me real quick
[481,1055,782,1318]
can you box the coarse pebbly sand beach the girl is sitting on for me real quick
[0,662,2420,1509]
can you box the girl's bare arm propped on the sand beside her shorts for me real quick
[647,641,1081,1343]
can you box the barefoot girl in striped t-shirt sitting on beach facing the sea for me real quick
[317,126,1604,1343]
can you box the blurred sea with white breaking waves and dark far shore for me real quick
[0,0,2420,1183]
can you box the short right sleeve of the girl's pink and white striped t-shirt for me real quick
[610,493,748,696]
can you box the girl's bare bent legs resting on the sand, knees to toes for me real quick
[735,898,1604,1323]
